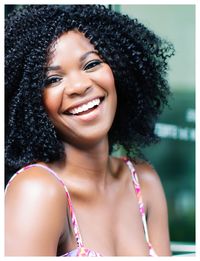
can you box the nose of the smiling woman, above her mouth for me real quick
[65,71,92,96]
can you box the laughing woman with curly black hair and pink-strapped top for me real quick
[5,5,173,256]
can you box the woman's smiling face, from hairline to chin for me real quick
[44,31,117,146]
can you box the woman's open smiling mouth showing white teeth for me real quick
[64,97,104,116]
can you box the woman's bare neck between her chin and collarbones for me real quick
[57,138,111,187]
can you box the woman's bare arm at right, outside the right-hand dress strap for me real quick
[137,163,171,256]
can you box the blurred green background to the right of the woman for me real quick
[5,5,195,254]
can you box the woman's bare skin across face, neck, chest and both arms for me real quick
[5,31,171,256]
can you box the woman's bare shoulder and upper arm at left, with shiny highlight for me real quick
[5,167,67,256]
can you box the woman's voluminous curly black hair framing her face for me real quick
[5,5,174,183]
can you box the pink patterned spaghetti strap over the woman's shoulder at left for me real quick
[5,163,83,247]
